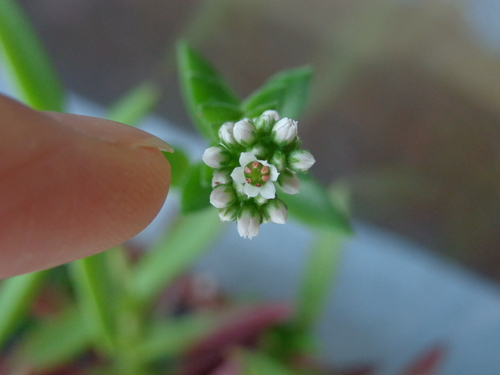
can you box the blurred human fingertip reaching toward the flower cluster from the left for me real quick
[0,96,170,278]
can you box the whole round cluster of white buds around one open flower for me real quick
[202,110,315,238]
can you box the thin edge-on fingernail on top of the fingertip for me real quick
[43,112,174,152]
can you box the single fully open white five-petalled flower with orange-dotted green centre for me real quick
[231,152,279,199]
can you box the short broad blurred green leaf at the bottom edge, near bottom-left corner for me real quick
[17,306,90,371]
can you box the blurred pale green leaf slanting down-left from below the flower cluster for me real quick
[131,207,224,301]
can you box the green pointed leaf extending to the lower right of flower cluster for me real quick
[280,175,352,234]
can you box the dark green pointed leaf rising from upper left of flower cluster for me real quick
[177,42,240,140]
